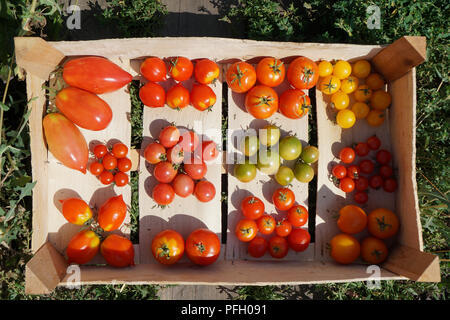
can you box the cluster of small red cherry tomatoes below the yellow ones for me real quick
[331,136,397,204]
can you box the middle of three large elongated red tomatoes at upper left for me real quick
[55,87,112,131]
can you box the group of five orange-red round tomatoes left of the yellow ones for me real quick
[226,57,319,119]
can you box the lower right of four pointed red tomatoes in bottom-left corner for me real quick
[100,234,134,268]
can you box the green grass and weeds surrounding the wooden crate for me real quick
[0,0,450,300]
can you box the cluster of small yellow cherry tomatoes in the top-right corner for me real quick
[318,60,392,129]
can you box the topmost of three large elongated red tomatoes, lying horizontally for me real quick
[63,57,132,94]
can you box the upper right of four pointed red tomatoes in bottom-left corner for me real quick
[97,195,127,231]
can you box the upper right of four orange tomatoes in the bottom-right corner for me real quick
[367,208,400,239]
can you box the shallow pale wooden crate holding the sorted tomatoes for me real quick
[15,37,440,294]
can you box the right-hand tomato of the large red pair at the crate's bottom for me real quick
[186,229,220,266]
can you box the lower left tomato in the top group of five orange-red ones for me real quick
[245,85,278,119]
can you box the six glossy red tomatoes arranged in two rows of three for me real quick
[139,57,220,111]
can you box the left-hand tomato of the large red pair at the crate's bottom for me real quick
[151,229,185,265]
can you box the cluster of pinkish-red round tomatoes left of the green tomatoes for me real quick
[144,125,219,207]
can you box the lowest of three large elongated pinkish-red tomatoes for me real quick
[42,113,89,173]
